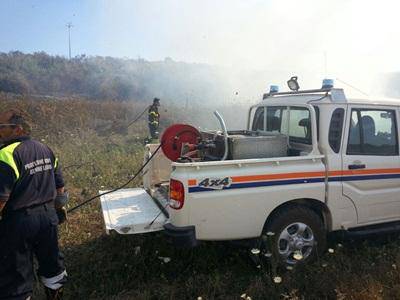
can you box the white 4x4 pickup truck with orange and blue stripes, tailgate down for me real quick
[101,80,400,264]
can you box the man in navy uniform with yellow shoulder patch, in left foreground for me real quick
[0,110,68,300]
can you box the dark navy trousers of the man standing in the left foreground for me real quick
[0,203,65,299]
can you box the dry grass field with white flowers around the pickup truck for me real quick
[0,97,400,300]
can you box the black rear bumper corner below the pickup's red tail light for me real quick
[164,223,199,248]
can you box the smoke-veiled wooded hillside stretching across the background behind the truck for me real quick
[0,51,400,107]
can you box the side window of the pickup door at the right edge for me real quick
[347,109,399,156]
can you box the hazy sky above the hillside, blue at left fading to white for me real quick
[0,0,400,93]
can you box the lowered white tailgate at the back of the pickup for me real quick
[100,188,168,234]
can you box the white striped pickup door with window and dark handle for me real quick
[341,105,400,224]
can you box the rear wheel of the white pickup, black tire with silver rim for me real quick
[262,206,327,265]
